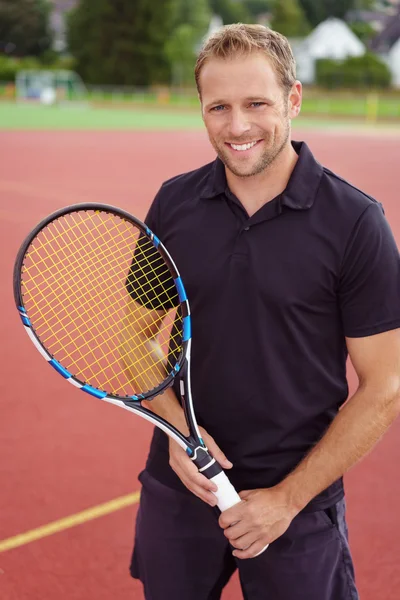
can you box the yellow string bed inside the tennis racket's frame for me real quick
[22,211,182,396]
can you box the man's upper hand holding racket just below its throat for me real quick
[169,427,232,506]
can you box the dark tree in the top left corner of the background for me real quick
[0,0,52,56]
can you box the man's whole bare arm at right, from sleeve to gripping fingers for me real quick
[220,329,400,558]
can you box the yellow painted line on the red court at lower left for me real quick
[0,492,140,552]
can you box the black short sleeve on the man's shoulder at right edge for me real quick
[339,203,400,337]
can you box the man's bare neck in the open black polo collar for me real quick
[225,141,298,217]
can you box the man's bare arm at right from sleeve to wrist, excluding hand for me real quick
[276,329,400,510]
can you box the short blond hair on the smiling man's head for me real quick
[194,23,296,94]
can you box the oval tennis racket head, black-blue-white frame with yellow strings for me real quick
[14,203,191,401]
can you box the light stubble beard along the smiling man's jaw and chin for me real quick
[210,118,290,178]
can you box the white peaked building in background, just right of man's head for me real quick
[289,17,366,85]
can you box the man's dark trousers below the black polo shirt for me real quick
[131,471,358,600]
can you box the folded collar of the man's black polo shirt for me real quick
[200,141,323,210]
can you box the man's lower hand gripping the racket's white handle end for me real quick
[219,486,299,558]
